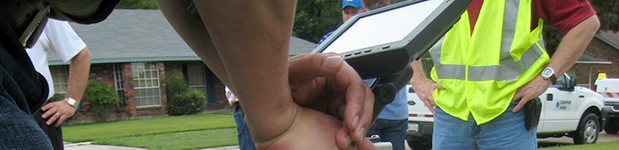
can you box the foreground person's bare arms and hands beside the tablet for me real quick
[158,0,373,149]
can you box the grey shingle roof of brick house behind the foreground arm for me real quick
[48,9,315,65]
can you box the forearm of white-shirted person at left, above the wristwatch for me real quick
[66,47,91,103]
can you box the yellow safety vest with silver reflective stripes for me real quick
[430,0,550,125]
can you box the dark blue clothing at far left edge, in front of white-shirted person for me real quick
[0,5,52,150]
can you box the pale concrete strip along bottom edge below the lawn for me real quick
[64,142,239,150]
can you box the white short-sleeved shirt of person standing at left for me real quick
[26,19,86,99]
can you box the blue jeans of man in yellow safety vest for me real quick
[432,104,537,150]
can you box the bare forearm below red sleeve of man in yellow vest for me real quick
[548,15,600,76]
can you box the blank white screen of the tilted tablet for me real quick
[322,0,444,53]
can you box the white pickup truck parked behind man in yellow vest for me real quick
[405,74,606,150]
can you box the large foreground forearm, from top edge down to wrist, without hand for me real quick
[188,0,296,145]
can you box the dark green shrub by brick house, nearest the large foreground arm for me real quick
[167,72,205,116]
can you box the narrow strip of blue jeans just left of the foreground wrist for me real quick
[232,103,256,150]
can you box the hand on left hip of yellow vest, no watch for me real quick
[411,76,445,114]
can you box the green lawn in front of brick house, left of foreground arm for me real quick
[62,111,237,149]
